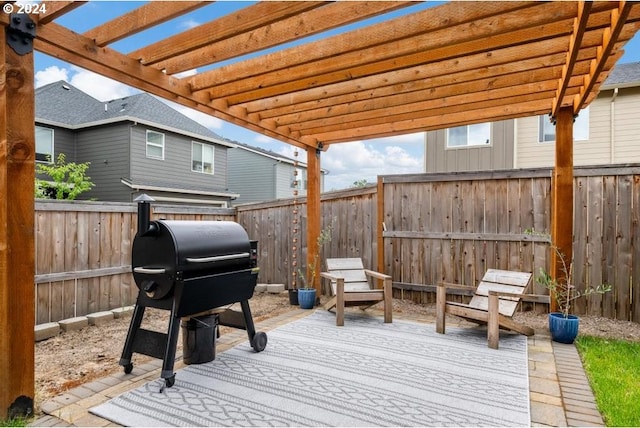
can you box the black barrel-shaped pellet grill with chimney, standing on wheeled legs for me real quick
[120,195,267,387]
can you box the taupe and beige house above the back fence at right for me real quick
[425,62,640,173]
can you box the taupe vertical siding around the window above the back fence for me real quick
[425,120,514,173]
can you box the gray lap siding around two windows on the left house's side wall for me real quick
[130,125,227,191]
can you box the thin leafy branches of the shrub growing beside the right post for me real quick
[525,229,612,318]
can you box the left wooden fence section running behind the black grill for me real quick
[35,201,235,324]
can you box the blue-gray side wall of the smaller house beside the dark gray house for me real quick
[228,148,281,204]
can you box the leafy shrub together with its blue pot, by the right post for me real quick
[536,244,612,343]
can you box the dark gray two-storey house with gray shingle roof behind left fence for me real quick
[35,81,239,207]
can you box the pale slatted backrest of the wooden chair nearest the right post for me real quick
[469,269,532,317]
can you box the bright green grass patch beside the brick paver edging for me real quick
[575,336,640,427]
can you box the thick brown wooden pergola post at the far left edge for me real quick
[0,27,35,420]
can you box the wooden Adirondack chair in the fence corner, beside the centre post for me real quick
[320,258,392,326]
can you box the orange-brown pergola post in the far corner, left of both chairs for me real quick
[307,147,322,296]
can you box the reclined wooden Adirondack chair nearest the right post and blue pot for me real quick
[436,269,542,349]
